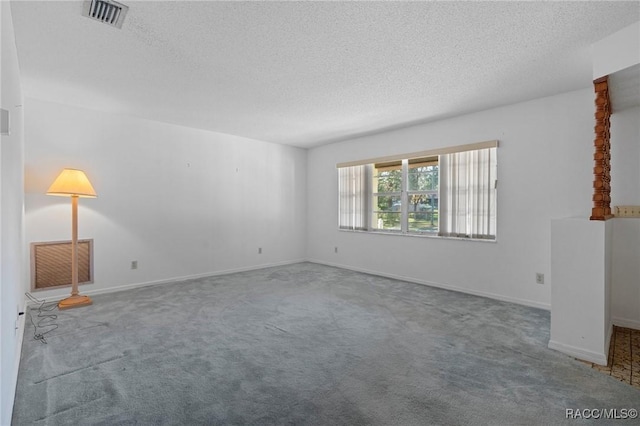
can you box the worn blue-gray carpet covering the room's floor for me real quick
[13,263,640,425]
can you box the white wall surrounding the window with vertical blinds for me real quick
[307,89,594,309]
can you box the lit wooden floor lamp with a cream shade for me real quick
[47,169,96,309]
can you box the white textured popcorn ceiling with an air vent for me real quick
[11,0,640,147]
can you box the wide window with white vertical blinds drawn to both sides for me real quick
[338,141,497,239]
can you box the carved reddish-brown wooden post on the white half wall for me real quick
[591,76,612,220]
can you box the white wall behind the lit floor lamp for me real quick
[25,98,307,298]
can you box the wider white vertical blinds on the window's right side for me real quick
[439,148,497,239]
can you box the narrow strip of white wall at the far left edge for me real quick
[0,1,24,425]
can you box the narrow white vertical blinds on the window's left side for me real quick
[338,165,368,230]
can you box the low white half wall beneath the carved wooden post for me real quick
[549,217,612,365]
